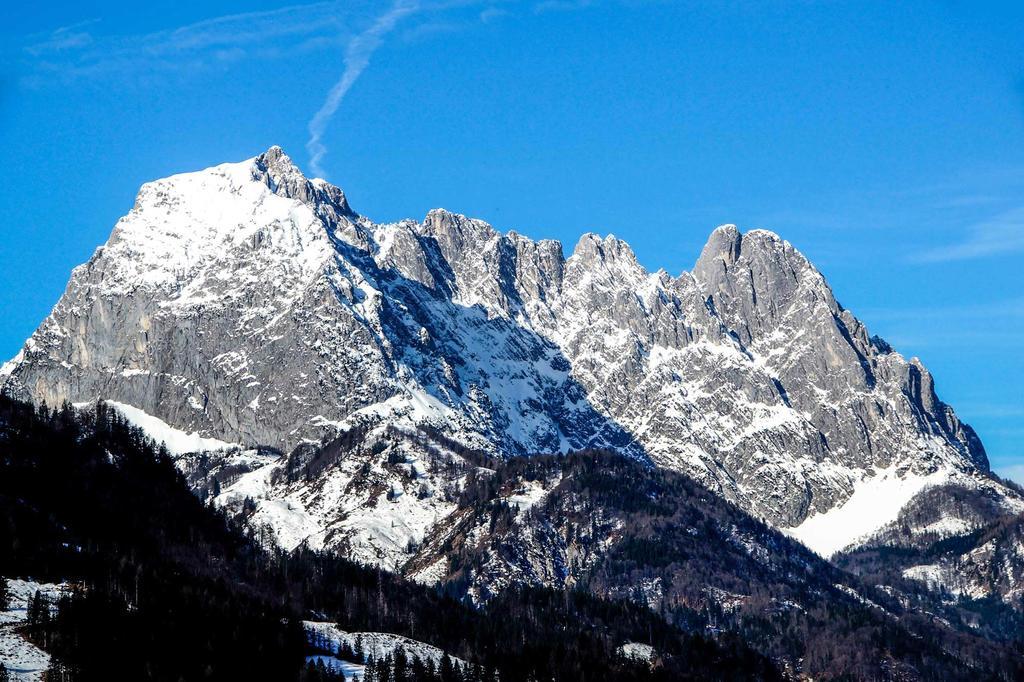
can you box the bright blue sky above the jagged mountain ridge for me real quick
[0,0,1024,480]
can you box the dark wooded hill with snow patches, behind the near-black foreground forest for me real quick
[402,452,1022,680]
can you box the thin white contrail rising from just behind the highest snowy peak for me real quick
[306,0,420,177]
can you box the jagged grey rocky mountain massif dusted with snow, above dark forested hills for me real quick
[0,147,1021,566]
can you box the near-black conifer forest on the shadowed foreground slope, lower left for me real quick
[0,397,780,682]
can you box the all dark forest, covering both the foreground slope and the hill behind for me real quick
[8,397,1024,682]
